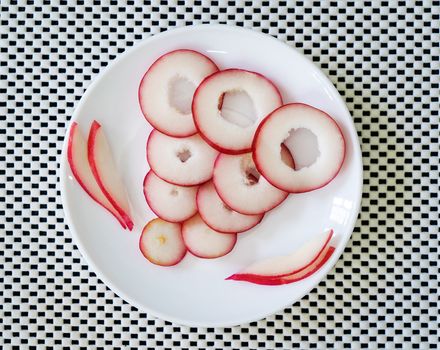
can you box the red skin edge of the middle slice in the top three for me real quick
[191,68,283,155]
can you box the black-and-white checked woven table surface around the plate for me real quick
[0,0,440,349]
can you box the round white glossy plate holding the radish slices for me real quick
[61,25,362,326]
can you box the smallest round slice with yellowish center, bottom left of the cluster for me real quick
[139,218,186,266]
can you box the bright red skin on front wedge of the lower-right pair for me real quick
[226,247,335,286]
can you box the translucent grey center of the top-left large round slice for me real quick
[168,76,196,114]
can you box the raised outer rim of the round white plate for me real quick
[59,24,364,328]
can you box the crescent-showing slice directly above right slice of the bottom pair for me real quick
[197,181,264,233]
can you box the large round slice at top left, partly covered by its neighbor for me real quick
[139,50,218,137]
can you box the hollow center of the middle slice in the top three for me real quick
[218,90,257,128]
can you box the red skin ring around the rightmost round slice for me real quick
[252,102,347,193]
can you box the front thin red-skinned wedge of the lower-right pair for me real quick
[226,246,335,286]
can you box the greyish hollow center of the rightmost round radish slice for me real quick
[284,128,320,170]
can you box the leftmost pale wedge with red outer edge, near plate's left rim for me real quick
[67,122,127,229]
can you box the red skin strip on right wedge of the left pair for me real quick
[87,120,134,231]
